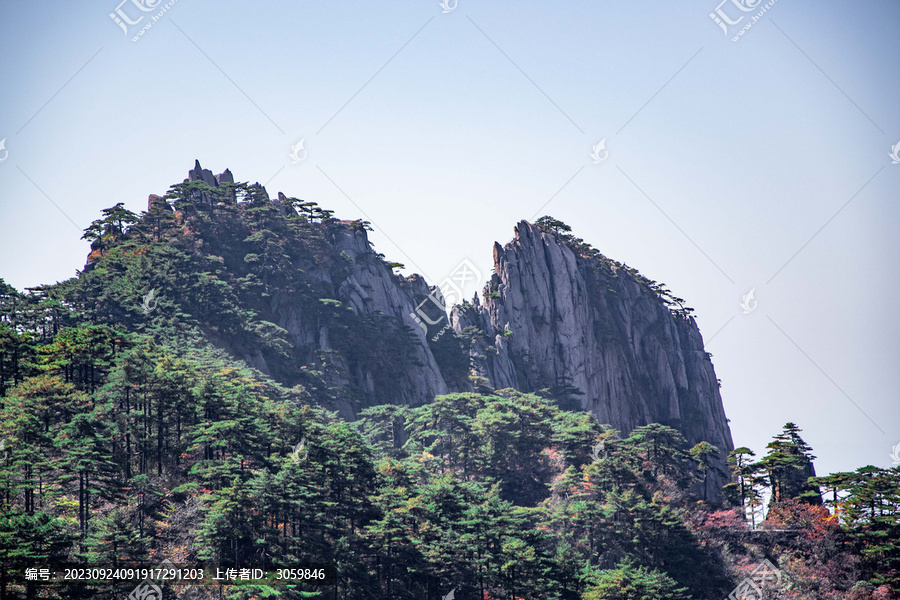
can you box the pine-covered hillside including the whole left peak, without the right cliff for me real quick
[0,165,900,600]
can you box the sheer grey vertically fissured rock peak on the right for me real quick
[451,221,734,497]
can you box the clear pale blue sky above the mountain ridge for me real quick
[0,0,900,473]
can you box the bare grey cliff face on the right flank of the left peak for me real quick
[196,162,458,418]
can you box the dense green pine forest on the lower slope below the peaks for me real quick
[0,322,736,599]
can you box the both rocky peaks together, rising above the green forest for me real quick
[100,162,733,486]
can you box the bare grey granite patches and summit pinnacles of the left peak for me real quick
[147,161,458,419]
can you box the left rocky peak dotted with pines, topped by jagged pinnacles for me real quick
[111,161,460,419]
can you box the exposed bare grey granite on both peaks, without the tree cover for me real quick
[130,162,733,492]
